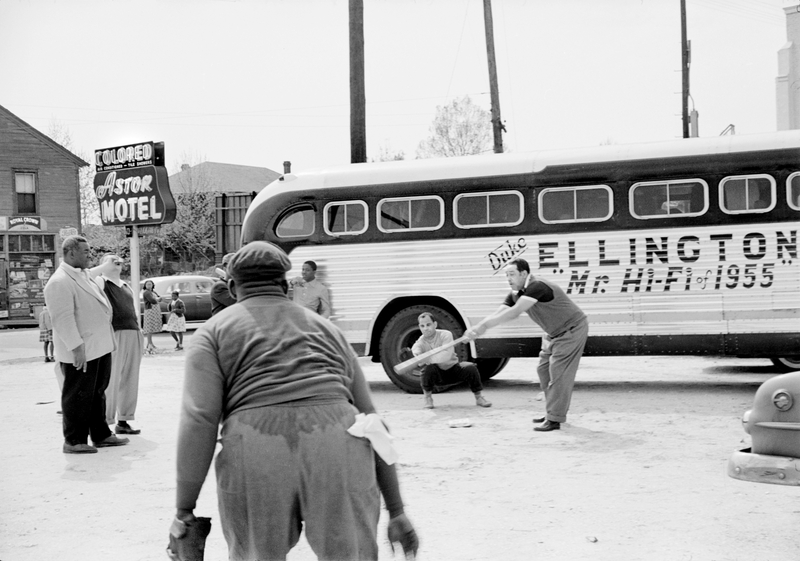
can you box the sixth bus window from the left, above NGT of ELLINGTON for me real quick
[630,179,708,218]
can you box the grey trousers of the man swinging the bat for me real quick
[536,319,589,423]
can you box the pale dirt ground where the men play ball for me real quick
[0,330,800,561]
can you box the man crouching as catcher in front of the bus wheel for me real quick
[410,312,492,409]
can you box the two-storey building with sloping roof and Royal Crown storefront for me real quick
[0,106,89,326]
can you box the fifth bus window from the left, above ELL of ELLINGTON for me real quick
[539,185,612,224]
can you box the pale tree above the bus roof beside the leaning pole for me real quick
[417,96,493,158]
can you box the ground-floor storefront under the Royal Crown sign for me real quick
[0,216,57,323]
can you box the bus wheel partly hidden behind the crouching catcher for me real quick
[379,305,468,393]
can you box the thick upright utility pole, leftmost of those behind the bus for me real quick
[350,0,367,164]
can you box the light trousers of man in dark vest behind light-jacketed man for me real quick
[106,329,144,425]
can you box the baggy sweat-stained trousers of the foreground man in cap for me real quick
[215,400,380,561]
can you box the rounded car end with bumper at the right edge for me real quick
[728,372,800,485]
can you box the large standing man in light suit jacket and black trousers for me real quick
[44,236,128,454]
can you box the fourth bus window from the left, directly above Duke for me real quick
[453,191,523,228]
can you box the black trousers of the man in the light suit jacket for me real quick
[61,353,111,445]
